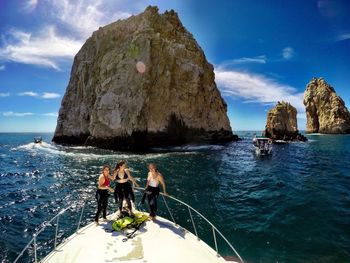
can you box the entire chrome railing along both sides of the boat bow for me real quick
[14,191,244,263]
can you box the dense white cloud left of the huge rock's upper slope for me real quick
[0,26,82,70]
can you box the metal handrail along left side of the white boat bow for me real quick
[14,201,86,263]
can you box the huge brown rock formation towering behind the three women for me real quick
[53,7,236,149]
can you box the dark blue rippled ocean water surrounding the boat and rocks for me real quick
[0,132,350,262]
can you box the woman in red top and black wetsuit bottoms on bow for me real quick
[95,165,114,224]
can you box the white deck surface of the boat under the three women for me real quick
[42,214,237,263]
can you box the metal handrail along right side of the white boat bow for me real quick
[134,187,244,263]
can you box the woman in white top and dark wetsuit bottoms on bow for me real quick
[142,163,167,220]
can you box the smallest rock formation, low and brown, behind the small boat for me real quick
[265,102,306,141]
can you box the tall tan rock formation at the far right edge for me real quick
[304,78,350,134]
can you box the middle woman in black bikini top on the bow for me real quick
[112,161,140,217]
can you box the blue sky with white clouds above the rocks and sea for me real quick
[0,0,350,132]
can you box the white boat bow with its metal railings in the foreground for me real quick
[14,188,243,263]
